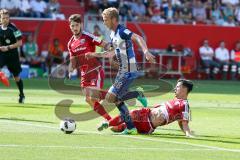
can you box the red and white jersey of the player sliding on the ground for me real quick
[159,98,190,124]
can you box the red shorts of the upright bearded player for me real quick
[81,68,105,89]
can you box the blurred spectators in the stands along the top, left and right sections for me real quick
[0,0,240,26]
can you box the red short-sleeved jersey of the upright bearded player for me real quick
[68,31,102,72]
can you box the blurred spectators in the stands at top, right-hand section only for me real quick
[86,0,240,26]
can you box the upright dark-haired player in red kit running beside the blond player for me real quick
[68,14,111,120]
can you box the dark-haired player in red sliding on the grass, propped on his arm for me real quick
[98,79,194,138]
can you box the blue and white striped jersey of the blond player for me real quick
[110,24,137,73]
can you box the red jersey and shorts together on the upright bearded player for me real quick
[68,31,104,88]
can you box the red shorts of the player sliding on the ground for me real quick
[130,108,154,134]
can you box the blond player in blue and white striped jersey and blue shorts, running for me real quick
[88,7,155,134]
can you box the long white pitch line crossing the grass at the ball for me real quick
[0,120,240,153]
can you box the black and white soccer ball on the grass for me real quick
[60,118,77,134]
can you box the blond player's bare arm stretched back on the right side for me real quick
[131,33,155,63]
